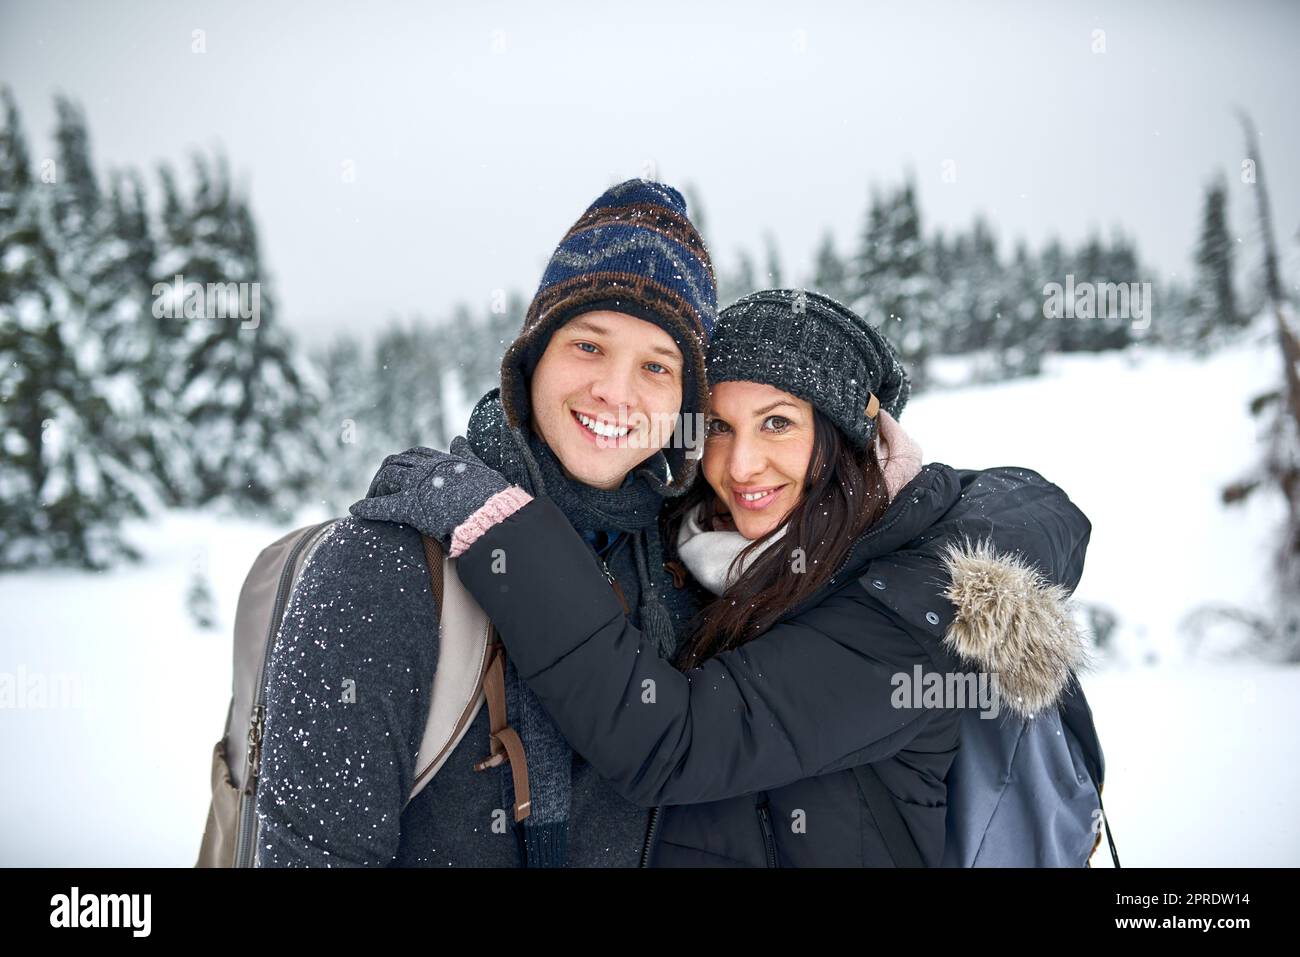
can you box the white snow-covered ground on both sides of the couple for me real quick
[0,330,1300,866]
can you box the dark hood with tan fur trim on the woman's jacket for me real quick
[832,463,1092,716]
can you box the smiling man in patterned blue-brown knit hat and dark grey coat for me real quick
[256,179,716,867]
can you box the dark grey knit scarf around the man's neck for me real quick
[465,389,676,867]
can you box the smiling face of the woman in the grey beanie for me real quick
[703,382,814,540]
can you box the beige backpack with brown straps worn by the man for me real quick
[195,519,529,867]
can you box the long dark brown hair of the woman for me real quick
[663,408,889,671]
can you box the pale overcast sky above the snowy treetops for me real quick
[0,0,1300,339]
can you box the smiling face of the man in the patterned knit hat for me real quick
[529,311,684,489]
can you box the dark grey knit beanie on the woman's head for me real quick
[707,289,911,449]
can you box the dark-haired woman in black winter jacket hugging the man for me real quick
[351,290,1091,866]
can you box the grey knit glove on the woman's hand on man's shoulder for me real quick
[348,436,510,549]
